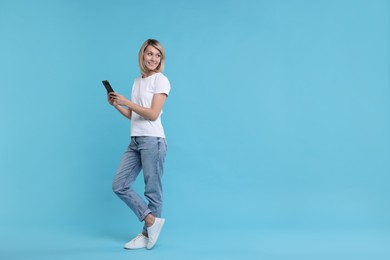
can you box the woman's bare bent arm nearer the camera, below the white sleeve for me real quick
[111,93,167,121]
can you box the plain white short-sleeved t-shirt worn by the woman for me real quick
[130,72,171,138]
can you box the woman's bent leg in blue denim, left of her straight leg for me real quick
[112,141,151,221]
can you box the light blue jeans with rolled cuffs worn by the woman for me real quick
[112,136,167,231]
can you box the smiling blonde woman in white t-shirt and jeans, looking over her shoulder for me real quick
[108,39,171,249]
